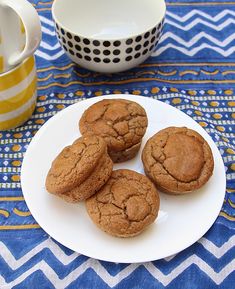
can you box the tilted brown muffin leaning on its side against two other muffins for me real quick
[46,136,113,203]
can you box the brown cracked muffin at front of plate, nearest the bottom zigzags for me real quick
[86,169,160,237]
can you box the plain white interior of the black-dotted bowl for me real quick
[52,0,166,39]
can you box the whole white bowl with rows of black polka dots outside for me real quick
[52,0,166,73]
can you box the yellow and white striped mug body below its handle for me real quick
[0,56,37,130]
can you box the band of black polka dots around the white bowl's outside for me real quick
[56,17,163,70]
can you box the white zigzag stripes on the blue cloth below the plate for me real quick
[0,236,235,289]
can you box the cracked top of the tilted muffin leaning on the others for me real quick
[46,136,107,193]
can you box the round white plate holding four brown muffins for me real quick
[21,94,226,263]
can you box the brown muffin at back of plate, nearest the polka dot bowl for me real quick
[79,99,148,163]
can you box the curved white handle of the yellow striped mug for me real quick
[0,0,42,66]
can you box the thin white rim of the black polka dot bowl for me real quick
[51,0,166,42]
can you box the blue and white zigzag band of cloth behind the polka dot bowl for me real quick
[36,9,235,61]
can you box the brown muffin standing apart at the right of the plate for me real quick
[142,127,214,194]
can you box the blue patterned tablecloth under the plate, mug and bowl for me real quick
[0,0,235,289]
